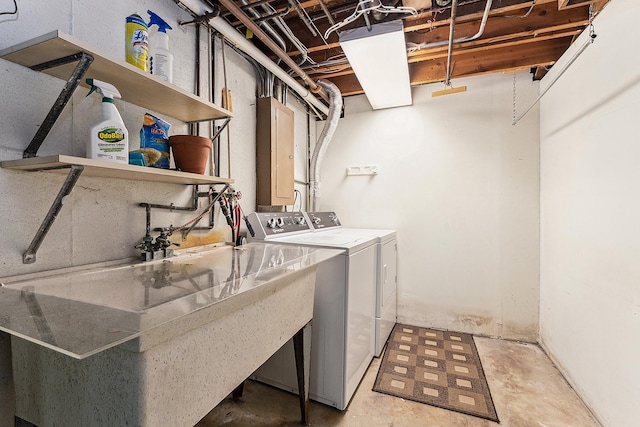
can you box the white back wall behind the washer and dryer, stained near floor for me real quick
[320,72,539,342]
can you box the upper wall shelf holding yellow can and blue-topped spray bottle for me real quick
[0,30,233,122]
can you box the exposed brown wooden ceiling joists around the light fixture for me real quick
[220,0,613,95]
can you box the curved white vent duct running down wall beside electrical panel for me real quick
[309,80,342,212]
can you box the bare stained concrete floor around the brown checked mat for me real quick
[197,338,600,427]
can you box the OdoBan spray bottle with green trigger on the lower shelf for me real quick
[87,79,129,163]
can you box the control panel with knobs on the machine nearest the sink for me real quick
[247,212,313,240]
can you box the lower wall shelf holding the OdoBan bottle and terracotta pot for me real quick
[0,155,233,185]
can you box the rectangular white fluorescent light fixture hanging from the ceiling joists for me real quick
[340,20,412,110]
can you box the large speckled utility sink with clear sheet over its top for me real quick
[0,242,341,426]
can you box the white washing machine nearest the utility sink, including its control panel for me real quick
[248,212,377,410]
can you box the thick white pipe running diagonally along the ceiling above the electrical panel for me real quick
[209,17,329,115]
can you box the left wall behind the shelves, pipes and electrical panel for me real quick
[0,0,315,426]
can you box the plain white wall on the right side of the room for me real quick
[540,0,640,427]
